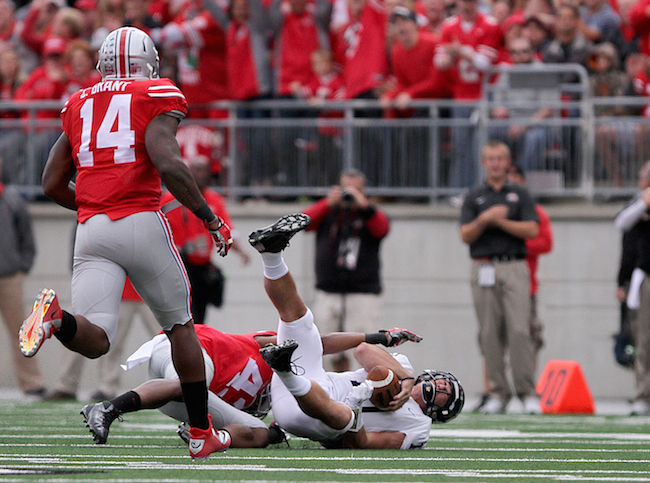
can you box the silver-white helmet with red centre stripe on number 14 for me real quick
[97,27,159,80]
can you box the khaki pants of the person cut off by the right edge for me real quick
[631,275,650,404]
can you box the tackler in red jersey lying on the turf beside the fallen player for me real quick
[82,325,410,448]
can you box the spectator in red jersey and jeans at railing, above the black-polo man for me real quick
[435,0,502,188]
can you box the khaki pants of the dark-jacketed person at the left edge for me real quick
[0,272,43,392]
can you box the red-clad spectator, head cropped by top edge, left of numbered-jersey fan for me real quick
[269,0,332,97]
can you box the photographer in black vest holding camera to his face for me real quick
[304,169,390,371]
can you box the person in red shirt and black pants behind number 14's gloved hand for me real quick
[160,156,249,324]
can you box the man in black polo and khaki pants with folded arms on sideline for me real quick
[460,141,540,414]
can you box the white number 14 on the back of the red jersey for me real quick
[77,94,135,167]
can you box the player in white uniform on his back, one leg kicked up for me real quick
[249,213,465,449]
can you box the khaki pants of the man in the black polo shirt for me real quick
[471,260,535,403]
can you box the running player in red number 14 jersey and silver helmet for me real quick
[19,27,232,458]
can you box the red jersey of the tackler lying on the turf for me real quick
[194,325,275,409]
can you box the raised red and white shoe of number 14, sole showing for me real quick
[18,288,63,357]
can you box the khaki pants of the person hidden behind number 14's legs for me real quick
[54,301,160,397]
